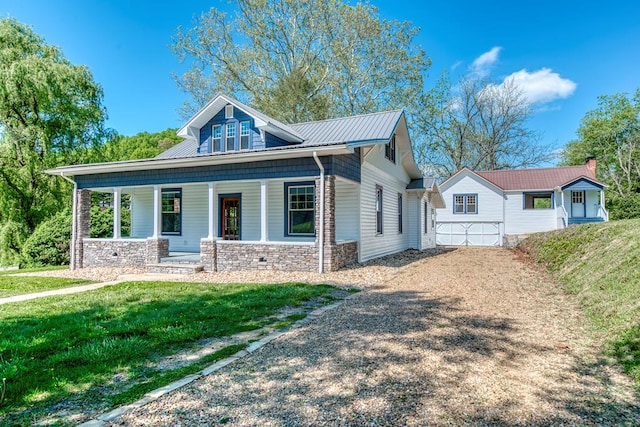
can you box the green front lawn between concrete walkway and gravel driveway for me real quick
[0,282,334,425]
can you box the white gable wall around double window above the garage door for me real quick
[438,173,504,222]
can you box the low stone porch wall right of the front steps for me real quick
[216,242,318,271]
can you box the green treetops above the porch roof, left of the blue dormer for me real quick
[99,129,183,162]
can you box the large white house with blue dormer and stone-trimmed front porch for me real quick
[47,94,445,271]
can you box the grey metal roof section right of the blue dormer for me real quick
[290,110,403,145]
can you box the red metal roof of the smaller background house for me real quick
[475,165,604,191]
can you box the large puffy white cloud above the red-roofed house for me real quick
[504,68,578,104]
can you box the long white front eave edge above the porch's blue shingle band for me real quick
[45,144,352,177]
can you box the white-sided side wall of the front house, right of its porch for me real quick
[359,162,409,261]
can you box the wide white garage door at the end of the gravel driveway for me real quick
[436,222,502,246]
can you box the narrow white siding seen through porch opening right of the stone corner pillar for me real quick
[335,179,360,241]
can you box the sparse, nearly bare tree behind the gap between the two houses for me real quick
[416,74,550,178]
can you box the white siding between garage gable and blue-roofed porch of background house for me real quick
[504,191,556,234]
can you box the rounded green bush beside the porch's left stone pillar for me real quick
[22,210,71,265]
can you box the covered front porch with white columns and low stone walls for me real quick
[72,175,359,271]
